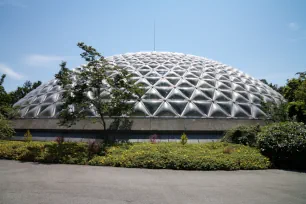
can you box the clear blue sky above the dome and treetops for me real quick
[0,0,306,91]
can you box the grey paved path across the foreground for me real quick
[0,160,306,204]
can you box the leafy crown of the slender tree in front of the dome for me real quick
[55,43,143,130]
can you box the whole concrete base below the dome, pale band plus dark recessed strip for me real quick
[13,118,264,143]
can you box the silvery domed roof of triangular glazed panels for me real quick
[15,52,282,119]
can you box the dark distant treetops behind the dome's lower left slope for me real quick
[9,81,41,105]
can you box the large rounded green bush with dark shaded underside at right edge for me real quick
[258,122,306,169]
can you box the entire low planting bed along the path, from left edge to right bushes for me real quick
[0,141,270,170]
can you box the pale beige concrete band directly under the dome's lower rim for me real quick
[13,118,264,131]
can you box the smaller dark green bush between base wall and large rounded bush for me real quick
[221,125,260,147]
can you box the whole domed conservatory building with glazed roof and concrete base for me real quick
[14,52,282,142]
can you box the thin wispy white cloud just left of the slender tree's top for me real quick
[24,54,74,67]
